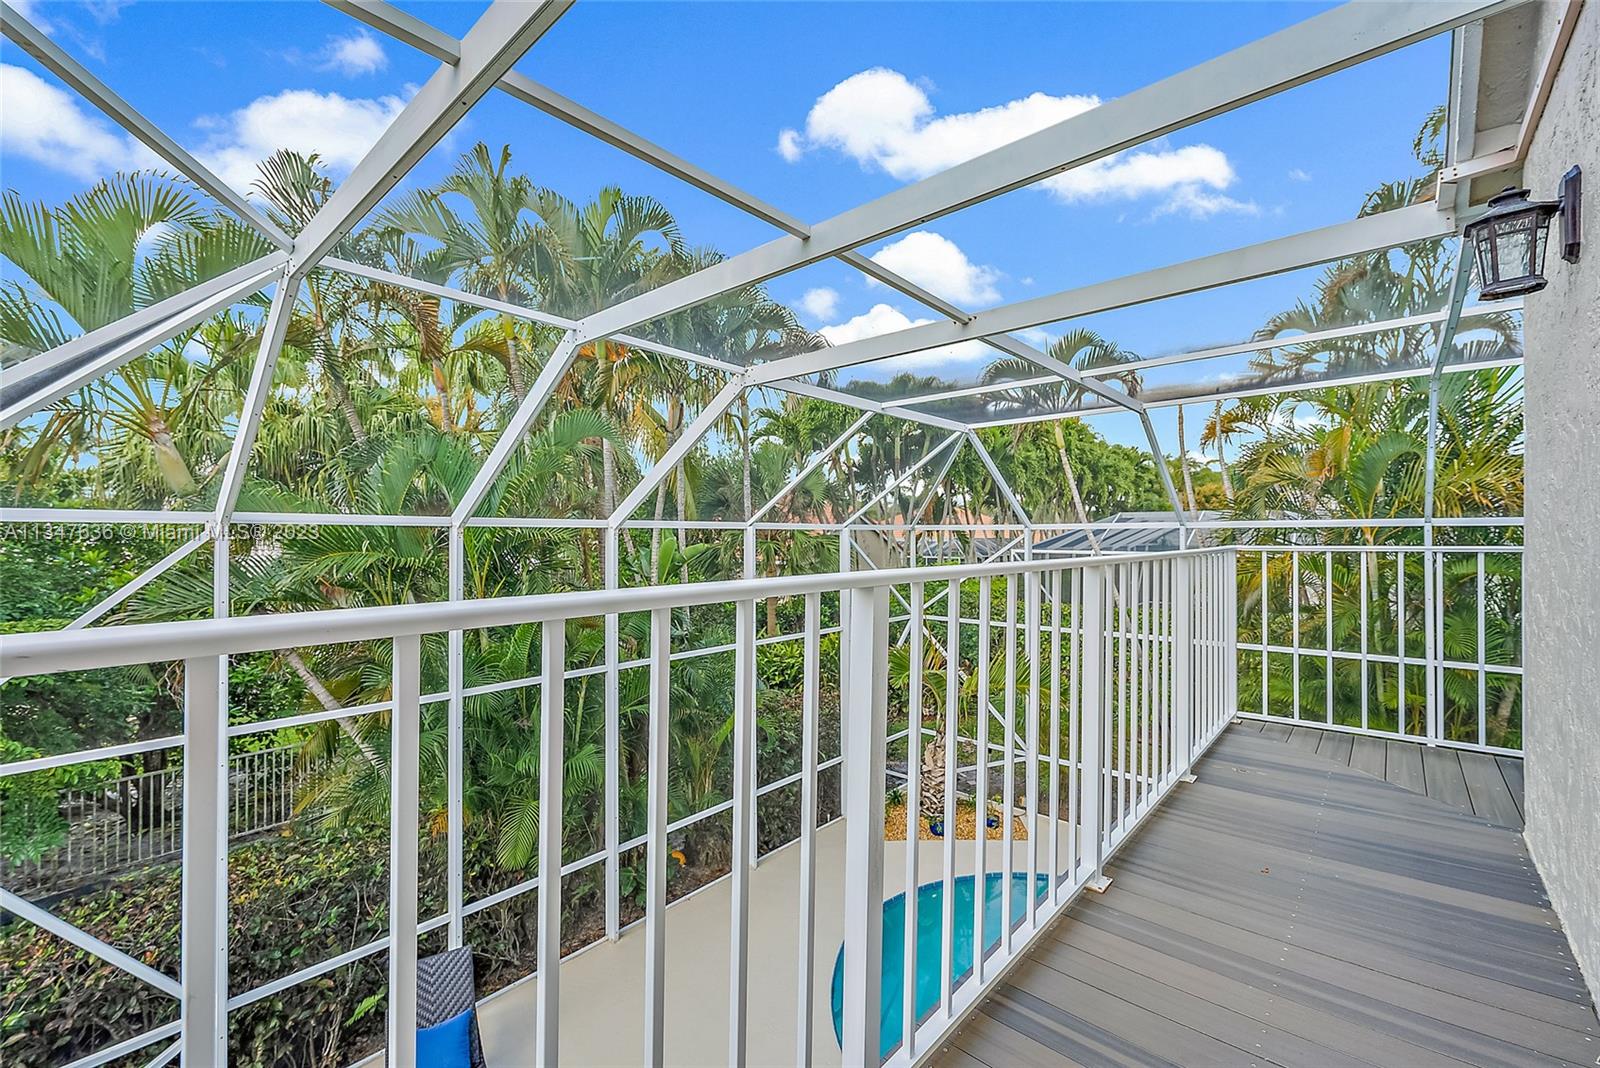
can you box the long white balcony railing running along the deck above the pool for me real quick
[0,548,1237,1065]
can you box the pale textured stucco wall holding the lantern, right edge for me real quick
[1525,0,1600,1016]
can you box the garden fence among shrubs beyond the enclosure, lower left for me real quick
[0,745,304,891]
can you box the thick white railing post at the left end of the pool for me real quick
[842,587,889,1065]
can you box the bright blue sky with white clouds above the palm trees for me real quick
[0,0,1448,451]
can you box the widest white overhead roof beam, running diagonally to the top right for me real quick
[566,0,1522,339]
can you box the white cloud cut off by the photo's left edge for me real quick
[0,64,162,181]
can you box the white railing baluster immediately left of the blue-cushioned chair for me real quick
[389,635,422,1068]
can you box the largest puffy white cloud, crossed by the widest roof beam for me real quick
[778,67,1253,217]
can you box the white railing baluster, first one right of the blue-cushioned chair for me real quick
[533,619,566,1065]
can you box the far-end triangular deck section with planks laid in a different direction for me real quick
[1235,719,1523,831]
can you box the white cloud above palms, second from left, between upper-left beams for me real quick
[197,90,405,192]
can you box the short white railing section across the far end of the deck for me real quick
[1238,545,1523,755]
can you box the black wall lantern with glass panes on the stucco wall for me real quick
[1466,166,1582,301]
